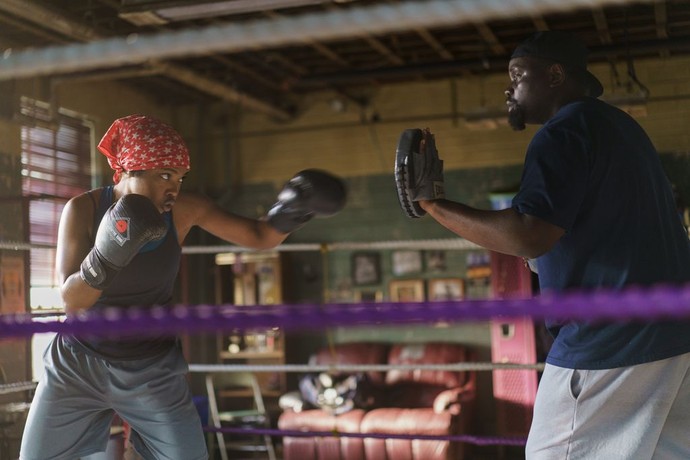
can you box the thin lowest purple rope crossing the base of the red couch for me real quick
[204,426,527,446]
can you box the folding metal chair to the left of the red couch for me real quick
[206,372,276,460]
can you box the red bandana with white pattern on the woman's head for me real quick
[98,115,189,184]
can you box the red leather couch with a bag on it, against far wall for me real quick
[278,342,476,460]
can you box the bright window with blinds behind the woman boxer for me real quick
[21,98,92,310]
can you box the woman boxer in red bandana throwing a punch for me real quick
[20,115,345,460]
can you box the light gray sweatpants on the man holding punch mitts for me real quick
[526,353,690,460]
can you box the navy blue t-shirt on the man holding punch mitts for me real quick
[513,98,690,369]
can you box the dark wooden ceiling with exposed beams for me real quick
[0,0,690,118]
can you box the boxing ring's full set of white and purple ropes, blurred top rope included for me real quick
[0,0,676,454]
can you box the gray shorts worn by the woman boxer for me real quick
[20,336,208,460]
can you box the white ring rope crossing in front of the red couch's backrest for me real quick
[189,362,544,373]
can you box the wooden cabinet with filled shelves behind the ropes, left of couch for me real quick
[216,252,286,397]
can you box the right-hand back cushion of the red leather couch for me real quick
[386,342,467,388]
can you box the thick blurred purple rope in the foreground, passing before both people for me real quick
[0,285,690,337]
